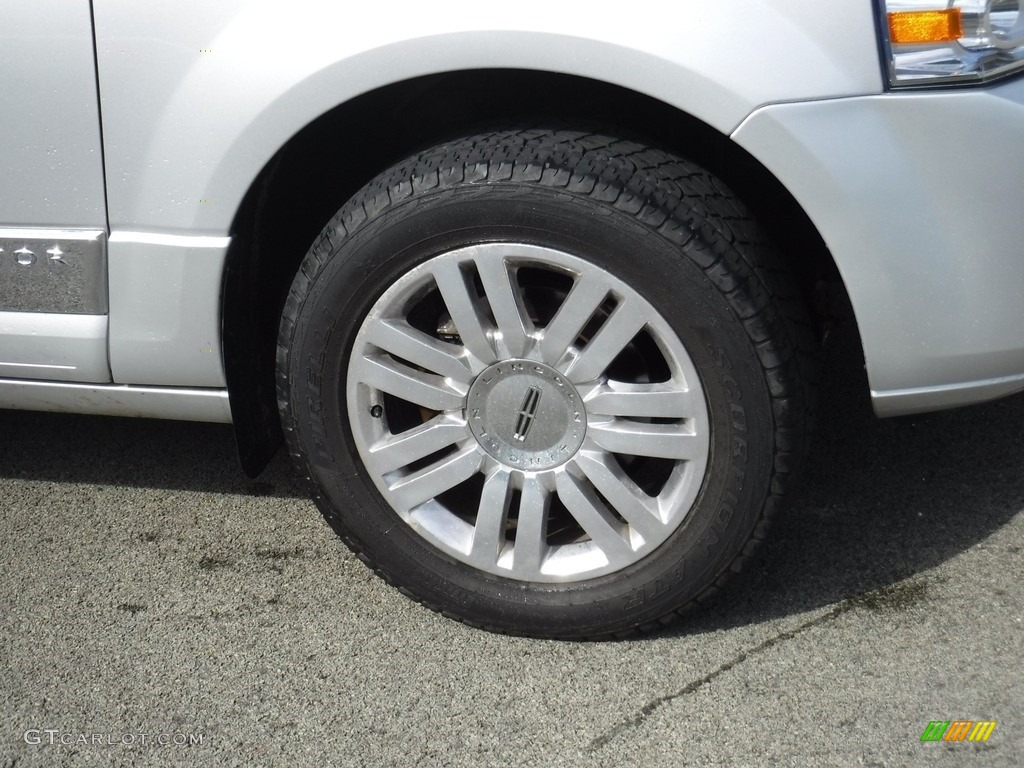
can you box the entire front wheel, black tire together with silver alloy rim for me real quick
[279,130,807,637]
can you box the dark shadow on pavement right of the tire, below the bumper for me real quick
[671,333,1024,634]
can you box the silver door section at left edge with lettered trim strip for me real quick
[0,0,111,382]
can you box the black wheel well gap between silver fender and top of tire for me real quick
[223,70,845,476]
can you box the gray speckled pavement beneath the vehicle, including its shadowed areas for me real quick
[0,331,1024,768]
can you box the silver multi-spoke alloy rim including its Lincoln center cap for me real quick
[346,243,710,583]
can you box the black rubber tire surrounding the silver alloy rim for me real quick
[278,129,811,638]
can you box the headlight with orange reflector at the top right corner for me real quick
[881,0,1024,87]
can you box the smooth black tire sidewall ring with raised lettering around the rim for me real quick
[284,183,774,635]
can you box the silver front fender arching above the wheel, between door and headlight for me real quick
[94,0,882,234]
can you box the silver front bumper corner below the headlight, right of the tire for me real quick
[733,80,1024,415]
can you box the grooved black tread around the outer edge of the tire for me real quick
[278,128,817,640]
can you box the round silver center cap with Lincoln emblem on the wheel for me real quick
[466,359,587,472]
